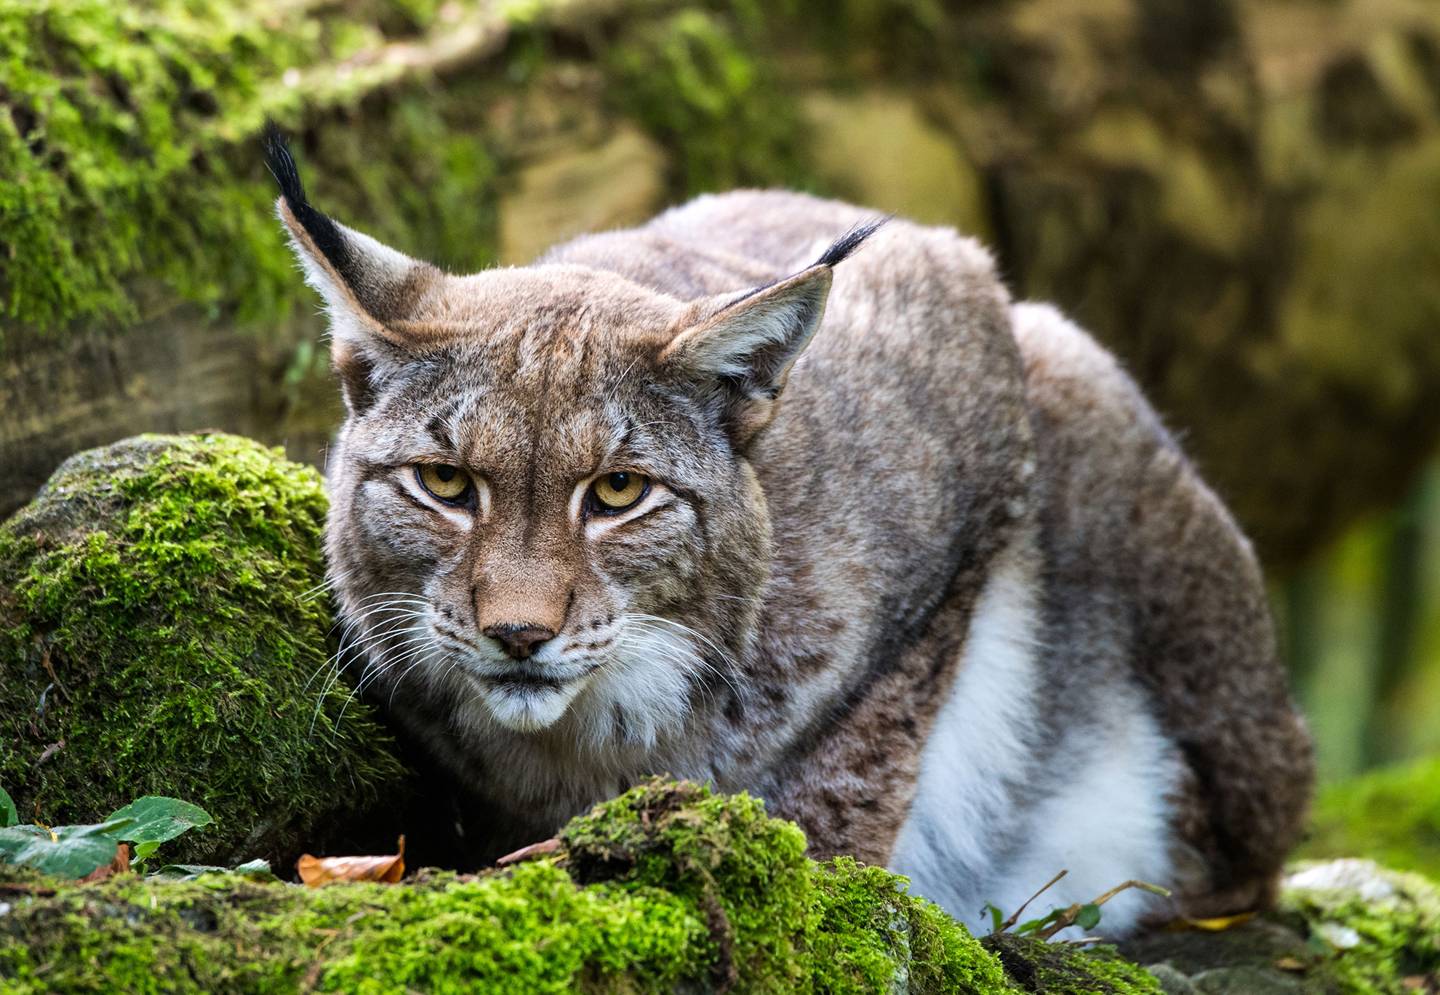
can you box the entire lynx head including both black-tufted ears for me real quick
[268,128,868,747]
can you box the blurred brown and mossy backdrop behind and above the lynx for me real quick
[0,0,1440,572]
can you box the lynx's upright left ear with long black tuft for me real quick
[265,124,444,412]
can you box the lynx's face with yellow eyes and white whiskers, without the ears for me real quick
[330,274,769,746]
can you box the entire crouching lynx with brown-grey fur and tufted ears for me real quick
[266,124,1312,935]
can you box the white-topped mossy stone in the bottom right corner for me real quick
[1280,860,1440,995]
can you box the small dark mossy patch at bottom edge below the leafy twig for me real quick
[981,933,1164,995]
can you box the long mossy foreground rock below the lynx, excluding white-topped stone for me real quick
[0,780,1159,995]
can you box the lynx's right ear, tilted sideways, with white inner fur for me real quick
[661,217,888,448]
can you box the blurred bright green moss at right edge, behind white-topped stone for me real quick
[1300,757,1440,880]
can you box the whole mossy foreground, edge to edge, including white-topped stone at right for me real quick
[0,782,1440,995]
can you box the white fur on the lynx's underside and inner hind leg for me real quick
[890,532,1178,936]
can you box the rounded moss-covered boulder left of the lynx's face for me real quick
[0,435,405,863]
